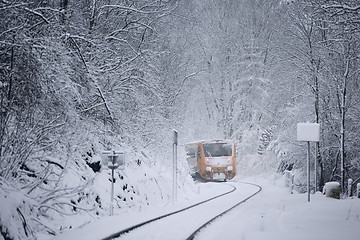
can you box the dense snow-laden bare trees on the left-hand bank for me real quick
[0,0,177,238]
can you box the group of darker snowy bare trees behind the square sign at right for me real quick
[278,0,359,191]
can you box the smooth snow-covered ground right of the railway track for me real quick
[199,176,360,240]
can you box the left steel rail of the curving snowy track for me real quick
[101,183,236,240]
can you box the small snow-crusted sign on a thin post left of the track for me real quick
[102,150,125,216]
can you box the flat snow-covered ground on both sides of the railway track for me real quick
[50,175,360,240]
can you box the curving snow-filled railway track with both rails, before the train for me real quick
[103,182,261,240]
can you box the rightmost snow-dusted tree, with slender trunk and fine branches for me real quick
[320,1,360,193]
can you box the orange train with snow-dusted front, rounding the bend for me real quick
[185,140,236,181]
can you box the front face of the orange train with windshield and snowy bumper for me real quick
[200,140,236,181]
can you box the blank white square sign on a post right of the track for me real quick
[297,123,320,202]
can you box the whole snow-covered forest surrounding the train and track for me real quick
[0,0,360,239]
